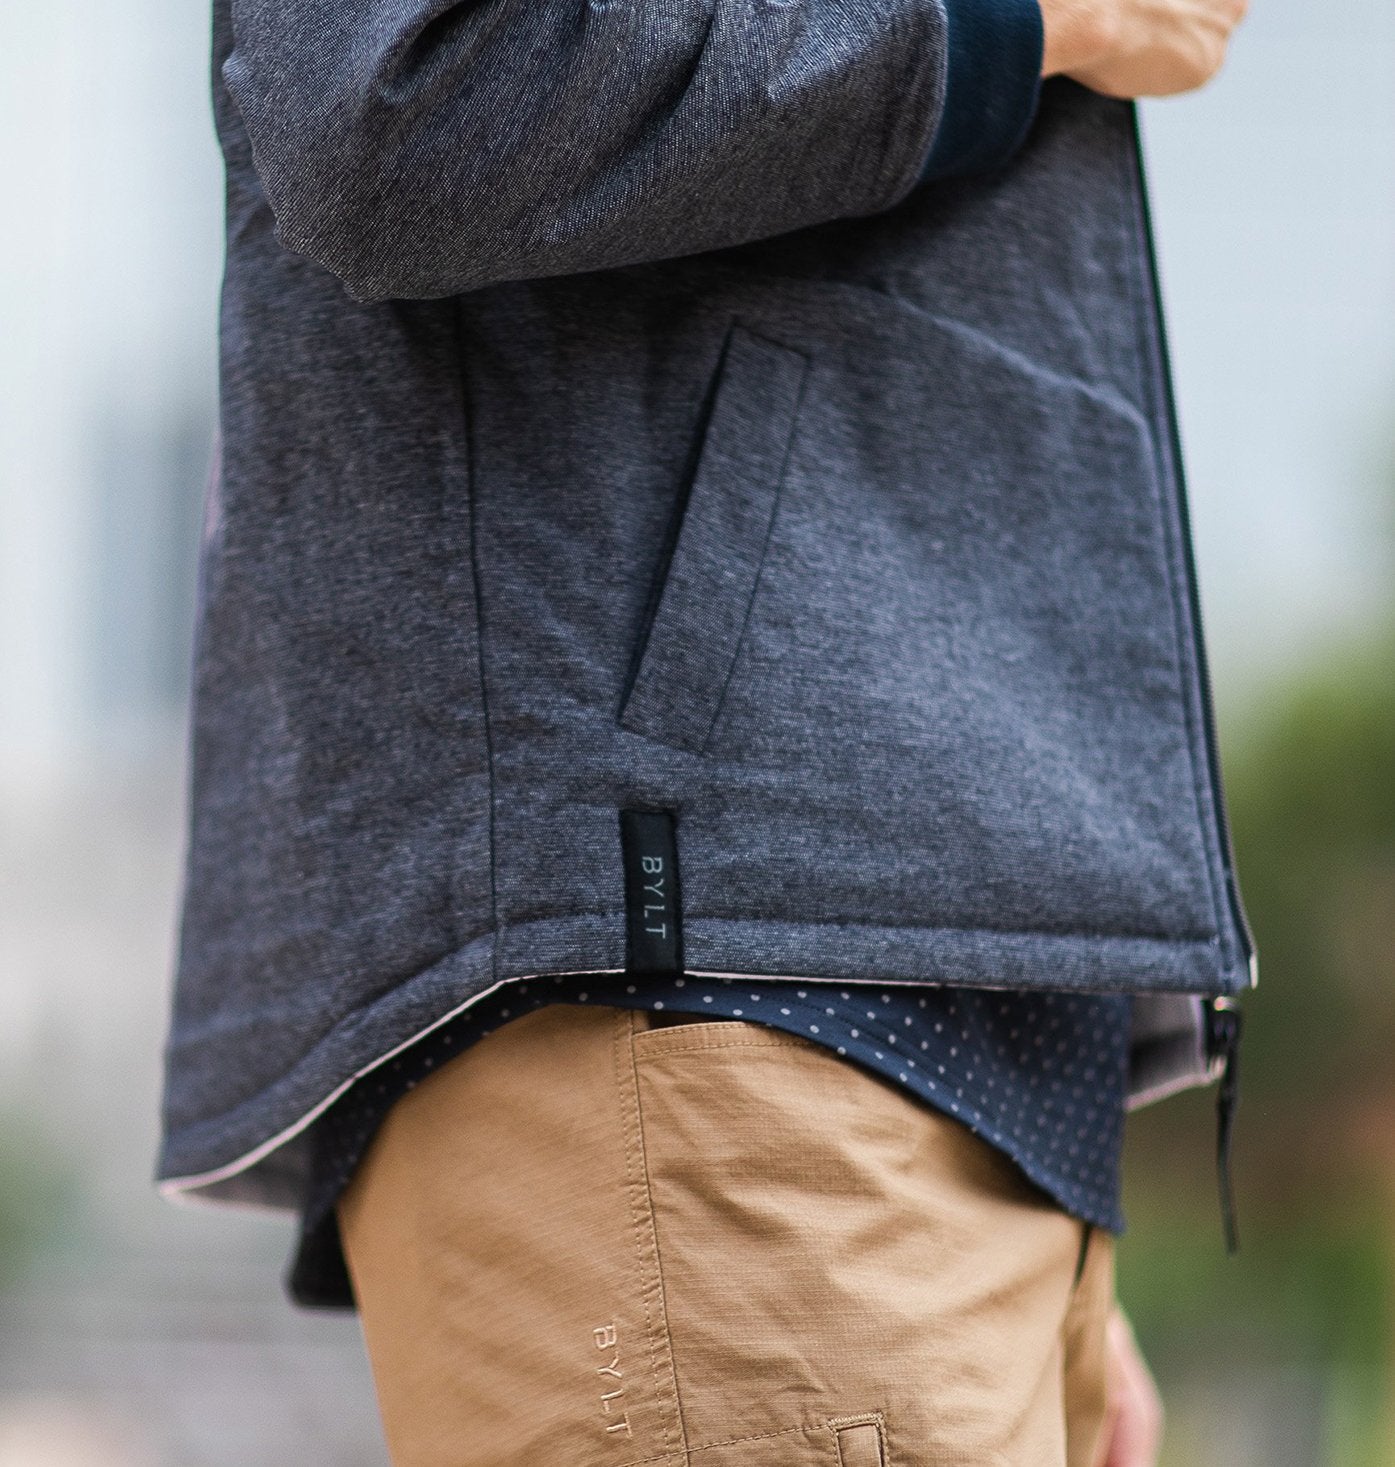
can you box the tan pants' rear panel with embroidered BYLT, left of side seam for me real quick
[339,1003,692,1467]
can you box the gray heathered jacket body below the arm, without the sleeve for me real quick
[160,71,1247,1204]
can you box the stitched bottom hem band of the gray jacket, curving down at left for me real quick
[155,912,1248,1212]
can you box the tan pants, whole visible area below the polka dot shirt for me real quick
[339,1003,1113,1467]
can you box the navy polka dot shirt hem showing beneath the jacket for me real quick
[288,974,1131,1307]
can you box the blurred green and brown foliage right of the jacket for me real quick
[1119,501,1395,1467]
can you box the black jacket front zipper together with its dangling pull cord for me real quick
[1129,103,1259,1253]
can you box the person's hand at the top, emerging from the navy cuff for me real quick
[1041,0,1248,97]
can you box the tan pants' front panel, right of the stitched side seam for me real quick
[632,1022,1103,1467]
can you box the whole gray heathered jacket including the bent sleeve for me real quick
[158,0,1251,1206]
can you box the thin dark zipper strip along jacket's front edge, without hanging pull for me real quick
[1131,104,1257,987]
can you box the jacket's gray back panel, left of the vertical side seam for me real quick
[161,20,491,1171]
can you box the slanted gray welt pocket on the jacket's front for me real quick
[619,324,808,754]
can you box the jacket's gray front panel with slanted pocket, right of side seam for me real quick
[461,85,1240,990]
